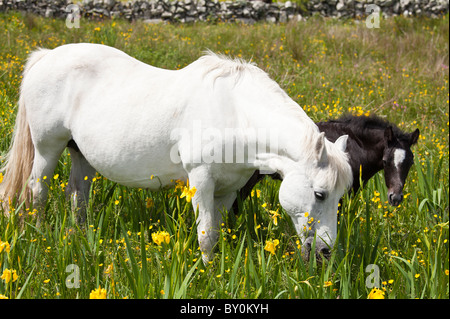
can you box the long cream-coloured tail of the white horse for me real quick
[0,50,48,208]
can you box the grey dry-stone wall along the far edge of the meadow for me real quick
[0,0,449,23]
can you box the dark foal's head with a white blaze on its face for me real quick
[383,126,420,206]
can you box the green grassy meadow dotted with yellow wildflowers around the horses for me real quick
[0,12,449,299]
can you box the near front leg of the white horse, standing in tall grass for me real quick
[188,167,222,264]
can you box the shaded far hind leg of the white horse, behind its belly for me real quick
[67,143,95,224]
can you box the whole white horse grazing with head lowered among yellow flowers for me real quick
[0,44,352,261]
